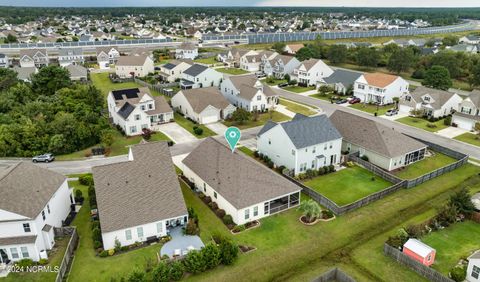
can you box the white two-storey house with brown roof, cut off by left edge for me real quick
[0,162,75,264]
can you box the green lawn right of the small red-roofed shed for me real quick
[421,221,480,275]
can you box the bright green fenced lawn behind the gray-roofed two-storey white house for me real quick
[304,166,392,206]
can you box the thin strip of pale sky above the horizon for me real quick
[0,0,480,7]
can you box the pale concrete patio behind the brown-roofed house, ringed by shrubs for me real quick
[160,227,205,257]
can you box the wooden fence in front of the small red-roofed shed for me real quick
[383,243,454,282]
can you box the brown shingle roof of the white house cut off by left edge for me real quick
[0,162,66,219]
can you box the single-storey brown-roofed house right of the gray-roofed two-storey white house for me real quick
[330,110,427,171]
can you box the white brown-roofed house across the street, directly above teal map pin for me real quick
[220,74,279,112]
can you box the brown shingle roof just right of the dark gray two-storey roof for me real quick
[330,110,427,158]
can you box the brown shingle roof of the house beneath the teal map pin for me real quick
[183,137,301,209]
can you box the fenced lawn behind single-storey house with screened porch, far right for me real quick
[393,152,456,179]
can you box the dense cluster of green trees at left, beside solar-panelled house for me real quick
[0,66,109,157]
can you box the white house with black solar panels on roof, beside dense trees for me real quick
[107,87,173,136]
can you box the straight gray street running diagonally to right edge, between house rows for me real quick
[274,88,480,159]
